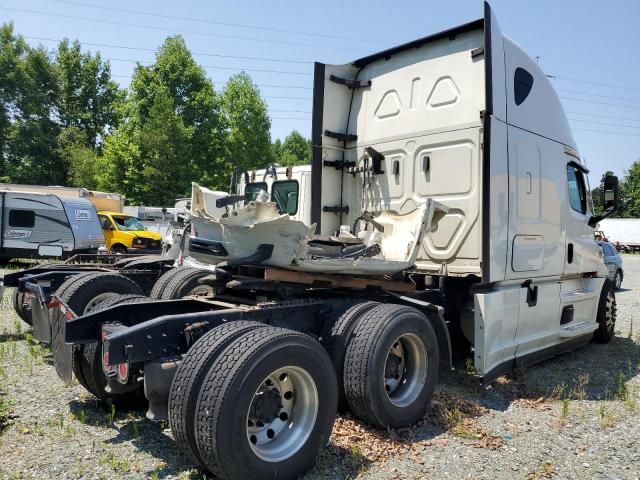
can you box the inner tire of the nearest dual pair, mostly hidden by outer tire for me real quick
[169,320,266,466]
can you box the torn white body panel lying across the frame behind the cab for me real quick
[192,188,448,275]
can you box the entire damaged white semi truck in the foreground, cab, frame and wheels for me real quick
[25,4,617,478]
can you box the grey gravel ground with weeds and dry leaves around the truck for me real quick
[0,256,640,479]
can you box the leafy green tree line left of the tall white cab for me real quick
[0,23,311,205]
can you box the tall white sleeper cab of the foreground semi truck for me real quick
[311,5,617,379]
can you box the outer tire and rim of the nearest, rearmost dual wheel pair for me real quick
[195,327,338,479]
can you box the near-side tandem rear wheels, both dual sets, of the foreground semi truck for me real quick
[169,302,439,478]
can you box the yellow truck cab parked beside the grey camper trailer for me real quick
[98,211,162,254]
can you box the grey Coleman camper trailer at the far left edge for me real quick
[0,191,104,262]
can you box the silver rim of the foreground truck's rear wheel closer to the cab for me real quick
[384,333,429,407]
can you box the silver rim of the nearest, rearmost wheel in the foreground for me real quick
[245,367,319,462]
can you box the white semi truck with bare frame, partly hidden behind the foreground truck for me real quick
[0,164,311,330]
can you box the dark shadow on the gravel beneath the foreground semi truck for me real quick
[53,335,640,479]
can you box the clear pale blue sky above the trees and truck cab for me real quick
[0,0,640,185]
